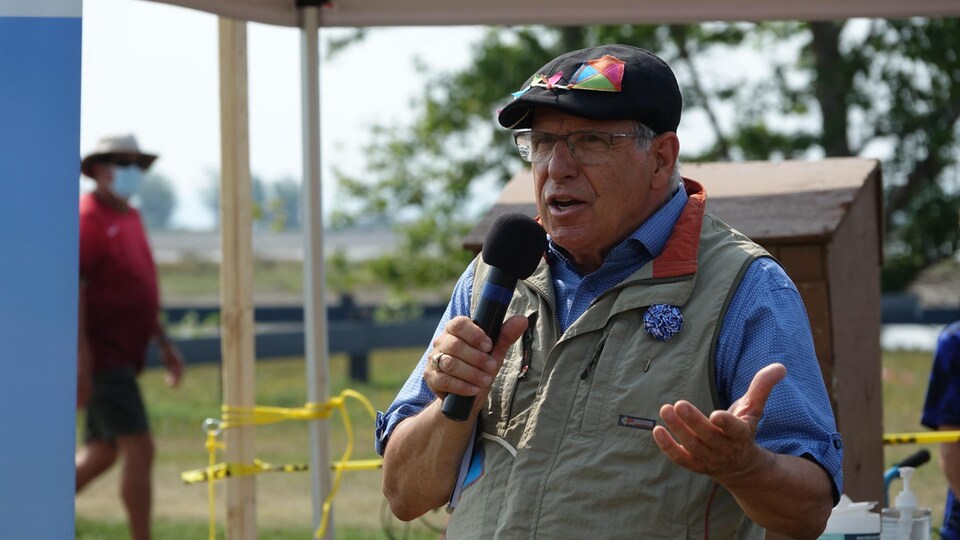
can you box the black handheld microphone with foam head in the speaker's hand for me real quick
[440,213,547,422]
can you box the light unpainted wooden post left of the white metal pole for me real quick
[219,17,257,540]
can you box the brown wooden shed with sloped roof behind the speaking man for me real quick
[464,158,883,501]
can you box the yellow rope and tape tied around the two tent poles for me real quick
[180,389,383,540]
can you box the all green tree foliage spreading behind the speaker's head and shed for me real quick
[336,19,960,296]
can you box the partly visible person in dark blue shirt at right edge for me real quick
[920,321,960,540]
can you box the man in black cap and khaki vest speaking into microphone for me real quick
[376,45,843,538]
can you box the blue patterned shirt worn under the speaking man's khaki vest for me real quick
[375,184,843,496]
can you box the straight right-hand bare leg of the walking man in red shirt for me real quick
[117,432,154,540]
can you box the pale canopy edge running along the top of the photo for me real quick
[150,0,960,26]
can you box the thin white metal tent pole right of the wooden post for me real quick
[300,5,333,540]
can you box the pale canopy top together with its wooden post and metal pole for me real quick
[141,0,960,538]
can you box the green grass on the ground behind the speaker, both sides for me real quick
[77,349,946,540]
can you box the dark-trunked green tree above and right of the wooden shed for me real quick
[692,19,960,290]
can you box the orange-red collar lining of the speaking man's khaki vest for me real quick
[653,178,707,278]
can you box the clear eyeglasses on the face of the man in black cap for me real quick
[513,129,643,165]
